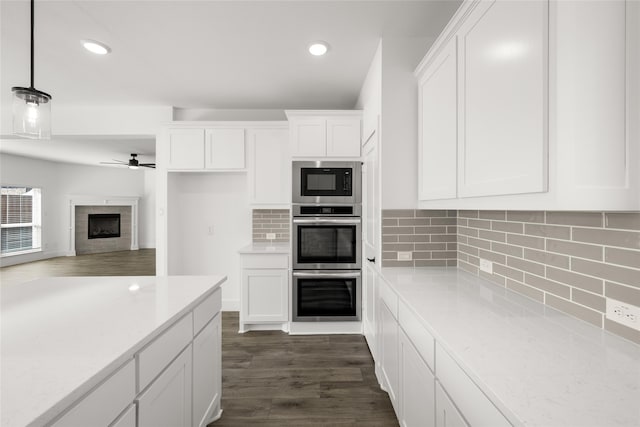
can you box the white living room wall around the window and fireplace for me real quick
[0,154,155,266]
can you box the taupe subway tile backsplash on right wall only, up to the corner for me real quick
[457,210,640,344]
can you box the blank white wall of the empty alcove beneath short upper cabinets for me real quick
[167,173,252,311]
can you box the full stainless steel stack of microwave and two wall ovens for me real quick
[292,161,362,322]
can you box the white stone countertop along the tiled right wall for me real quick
[381,267,640,427]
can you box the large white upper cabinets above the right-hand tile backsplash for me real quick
[416,0,640,211]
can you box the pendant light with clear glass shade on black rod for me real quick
[11,0,51,139]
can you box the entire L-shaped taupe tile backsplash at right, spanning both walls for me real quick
[382,209,640,344]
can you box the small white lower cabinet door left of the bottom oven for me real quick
[241,269,289,323]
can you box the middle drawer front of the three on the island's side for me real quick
[136,313,193,391]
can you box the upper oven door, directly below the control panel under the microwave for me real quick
[293,217,362,270]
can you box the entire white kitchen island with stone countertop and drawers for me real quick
[0,276,226,427]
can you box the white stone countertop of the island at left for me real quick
[0,276,226,427]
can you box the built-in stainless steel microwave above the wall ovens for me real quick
[291,161,362,204]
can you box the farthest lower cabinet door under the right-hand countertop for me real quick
[377,299,398,414]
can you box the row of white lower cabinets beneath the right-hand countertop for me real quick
[365,269,512,427]
